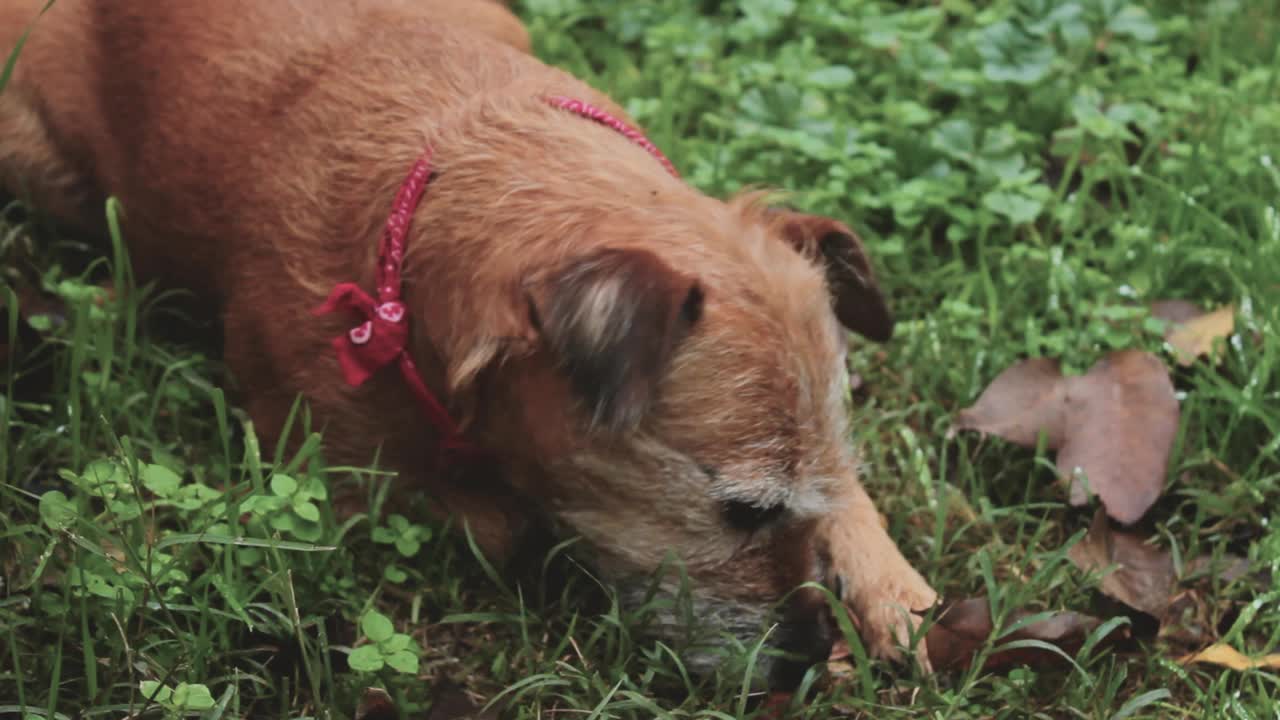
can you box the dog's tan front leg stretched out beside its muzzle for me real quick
[820,482,938,669]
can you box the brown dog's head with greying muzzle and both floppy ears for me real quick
[409,126,892,681]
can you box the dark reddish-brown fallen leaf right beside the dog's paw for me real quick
[925,597,1116,670]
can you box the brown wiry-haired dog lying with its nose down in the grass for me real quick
[0,0,936,676]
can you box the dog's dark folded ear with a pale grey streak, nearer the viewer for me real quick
[527,249,703,432]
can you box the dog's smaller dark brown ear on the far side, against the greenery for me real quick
[776,210,893,342]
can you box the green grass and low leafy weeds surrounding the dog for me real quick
[0,0,1280,719]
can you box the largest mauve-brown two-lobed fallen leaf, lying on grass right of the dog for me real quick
[956,350,1180,524]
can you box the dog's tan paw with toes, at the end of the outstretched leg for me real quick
[847,568,938,673]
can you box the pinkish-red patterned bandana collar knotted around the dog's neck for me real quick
[314,96,680,457]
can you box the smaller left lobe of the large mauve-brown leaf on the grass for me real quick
[956,357,1066,450]
